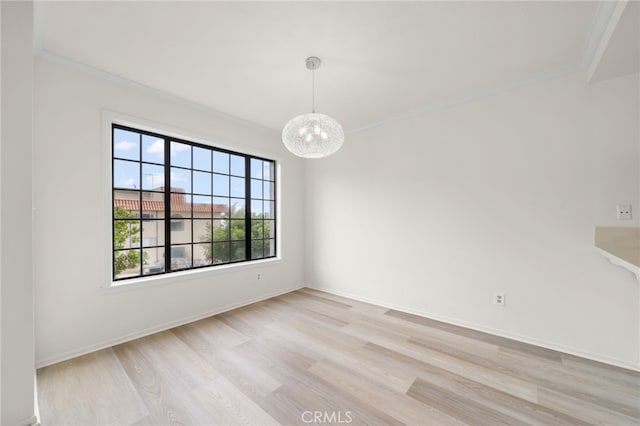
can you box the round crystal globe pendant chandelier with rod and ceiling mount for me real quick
[282,56,344,158]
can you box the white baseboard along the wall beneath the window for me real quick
[36,286,303,368]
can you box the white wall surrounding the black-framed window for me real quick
[34,54,304,366]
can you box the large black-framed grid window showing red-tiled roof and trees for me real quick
[112,124,277,280]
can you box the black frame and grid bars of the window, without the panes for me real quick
[111,123,278,282]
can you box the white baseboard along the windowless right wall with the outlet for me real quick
[306,285,640,372]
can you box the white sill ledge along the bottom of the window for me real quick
[102,257,282,293]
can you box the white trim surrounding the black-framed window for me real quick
[100,109,284,289]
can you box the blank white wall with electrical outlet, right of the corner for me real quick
[305,70,640,369]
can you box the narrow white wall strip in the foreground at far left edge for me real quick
[0,2,35,425]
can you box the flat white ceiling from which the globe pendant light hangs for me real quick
[36,1,632,132]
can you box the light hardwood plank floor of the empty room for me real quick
[37,289,640,426]
